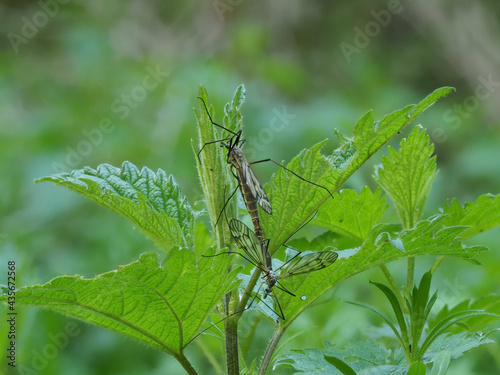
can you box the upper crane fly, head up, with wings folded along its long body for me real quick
[198,97,333,256]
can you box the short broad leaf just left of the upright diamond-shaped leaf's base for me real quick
[312,186,389,243]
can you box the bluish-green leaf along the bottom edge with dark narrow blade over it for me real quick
[275,340,408,375]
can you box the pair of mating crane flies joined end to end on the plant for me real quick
[198,97,338,320]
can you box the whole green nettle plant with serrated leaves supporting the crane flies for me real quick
[1,86,499,374]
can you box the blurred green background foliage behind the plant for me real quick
[0,0,500,375]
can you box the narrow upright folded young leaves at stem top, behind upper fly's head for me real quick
[191,85,240,249]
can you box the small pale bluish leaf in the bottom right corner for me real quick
[422,330,496,363]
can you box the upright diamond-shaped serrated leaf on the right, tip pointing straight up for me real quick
[374,127,437,228]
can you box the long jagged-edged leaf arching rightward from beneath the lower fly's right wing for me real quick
[277,215,487,328]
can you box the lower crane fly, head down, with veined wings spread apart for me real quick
[229,219,338,320]
